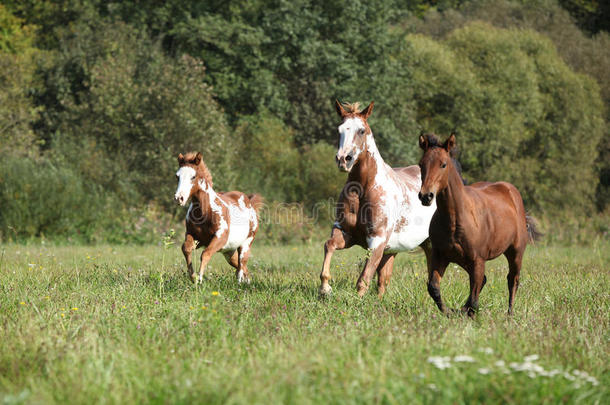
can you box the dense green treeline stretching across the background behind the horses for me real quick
[0,0,610,242]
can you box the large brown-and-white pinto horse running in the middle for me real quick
[319,100,435,297]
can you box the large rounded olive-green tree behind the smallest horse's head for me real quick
[38,23,233,207]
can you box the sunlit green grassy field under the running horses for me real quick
[0,243,610,404]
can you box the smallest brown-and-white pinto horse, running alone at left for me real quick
[174,152,263,284]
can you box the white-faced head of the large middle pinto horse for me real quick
[335,101,373,172]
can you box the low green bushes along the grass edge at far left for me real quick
[0,157,171,243]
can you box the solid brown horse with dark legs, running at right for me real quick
[418,134,541,317]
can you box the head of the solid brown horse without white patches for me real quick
[418,134,456,206]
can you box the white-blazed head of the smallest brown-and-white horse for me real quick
[174,152,212,206]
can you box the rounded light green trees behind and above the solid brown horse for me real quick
[400,23,603,214]
